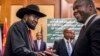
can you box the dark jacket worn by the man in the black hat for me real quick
[3,20,36,56]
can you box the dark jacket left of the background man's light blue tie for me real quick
[53,39,68,56]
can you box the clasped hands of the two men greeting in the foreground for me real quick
[37,48,58,56]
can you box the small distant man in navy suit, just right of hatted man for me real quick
[33,32,46,52]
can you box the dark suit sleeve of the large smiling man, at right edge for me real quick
[90,20,100,56]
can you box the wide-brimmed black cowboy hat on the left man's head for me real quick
[16,4,46,19]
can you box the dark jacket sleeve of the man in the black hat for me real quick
[9,27,36,56]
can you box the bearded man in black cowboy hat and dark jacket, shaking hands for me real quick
[3,4,46,56]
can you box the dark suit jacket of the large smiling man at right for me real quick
[72,15,100,56]
